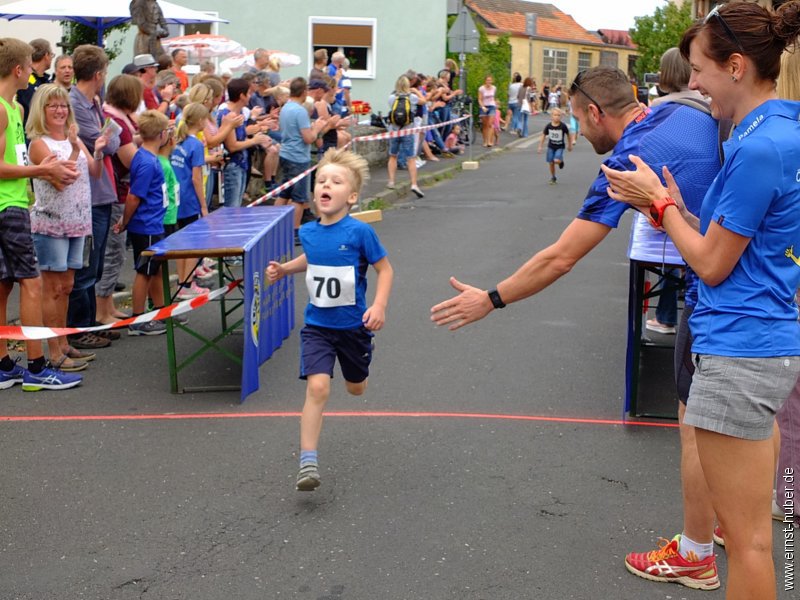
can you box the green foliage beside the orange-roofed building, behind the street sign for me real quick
[447,15,511,114]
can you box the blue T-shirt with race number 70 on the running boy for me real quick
[300,215,386,329]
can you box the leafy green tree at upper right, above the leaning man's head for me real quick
[631,2,692,80]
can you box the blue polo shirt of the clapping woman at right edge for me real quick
[689,100,800,357]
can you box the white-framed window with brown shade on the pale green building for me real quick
[308,17,376,79]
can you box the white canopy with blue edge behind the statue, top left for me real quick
[0,0,229,46]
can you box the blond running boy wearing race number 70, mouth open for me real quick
[267,150,393,491]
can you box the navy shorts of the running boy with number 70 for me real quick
[300,325,375,383]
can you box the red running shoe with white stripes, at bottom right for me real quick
[625,534,719,590]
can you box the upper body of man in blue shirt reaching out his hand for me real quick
[431,67,720,329]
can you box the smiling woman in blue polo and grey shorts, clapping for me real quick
[603,0,800,600]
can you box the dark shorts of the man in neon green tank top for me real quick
[0,206,39,281]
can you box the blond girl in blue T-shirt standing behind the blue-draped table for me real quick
[170,102,208,300]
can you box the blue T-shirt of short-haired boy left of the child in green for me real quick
[128,148,169,235]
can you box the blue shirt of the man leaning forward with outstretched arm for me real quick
[578,102,720,306]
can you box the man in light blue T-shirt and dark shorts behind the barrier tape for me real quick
[275,77,326,244]
